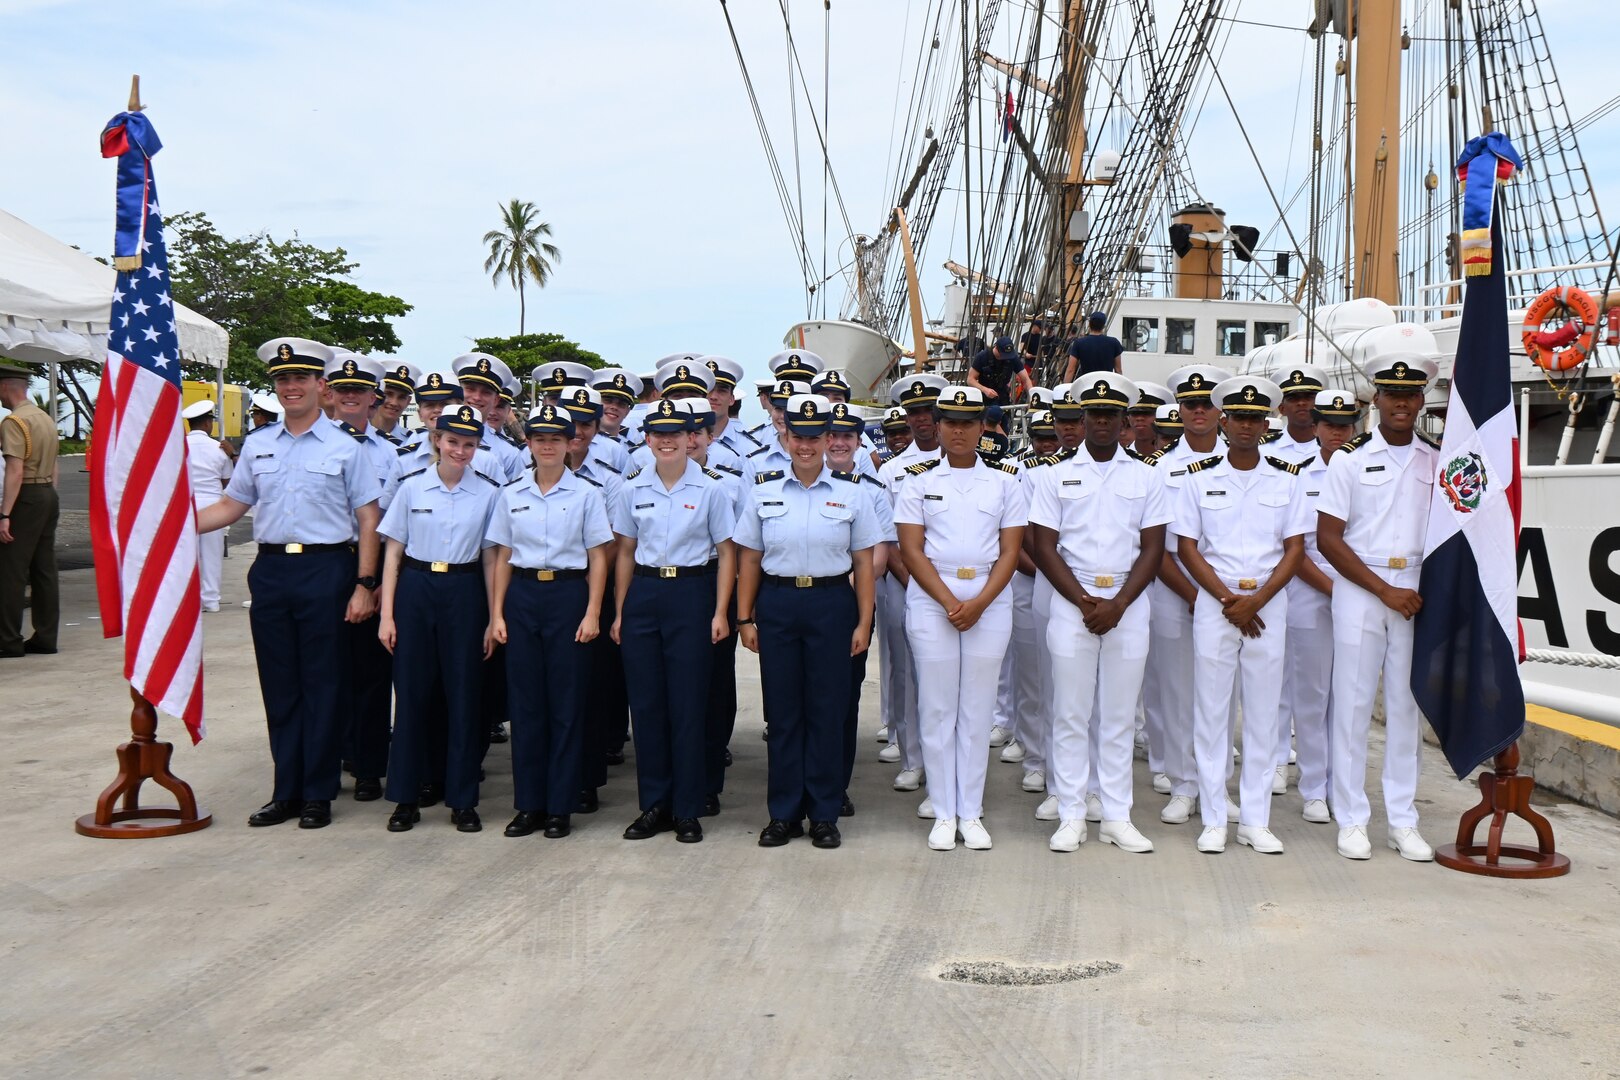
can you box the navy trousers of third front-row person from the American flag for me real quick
[505,578,591,814]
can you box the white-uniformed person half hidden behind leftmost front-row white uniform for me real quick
[878,372,951,792]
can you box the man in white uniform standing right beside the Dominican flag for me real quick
[1317,355,1437,863]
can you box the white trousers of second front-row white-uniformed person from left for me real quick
[1047,586,1149,821]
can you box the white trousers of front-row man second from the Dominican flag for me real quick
[1192,588,1288,829]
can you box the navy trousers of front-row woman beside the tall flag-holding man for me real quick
[385,567,489,810]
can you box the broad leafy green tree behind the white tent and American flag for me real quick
[164,212,411,387]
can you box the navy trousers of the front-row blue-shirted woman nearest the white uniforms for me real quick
[753,581,857,821]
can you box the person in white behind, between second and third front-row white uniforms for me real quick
[1142,364,1231,824]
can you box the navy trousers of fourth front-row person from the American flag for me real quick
[619,573,716,818]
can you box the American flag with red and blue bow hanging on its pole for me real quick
[89,112,203,743]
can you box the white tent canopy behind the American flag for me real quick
[0,210,230,368]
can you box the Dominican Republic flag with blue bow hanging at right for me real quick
[1411,133,1524,779]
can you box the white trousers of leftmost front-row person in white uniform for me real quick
[906,575,1013,819]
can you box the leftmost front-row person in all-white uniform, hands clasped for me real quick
[894,387,1027,850]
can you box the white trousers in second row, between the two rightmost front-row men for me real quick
[1277,573,1338,801]
